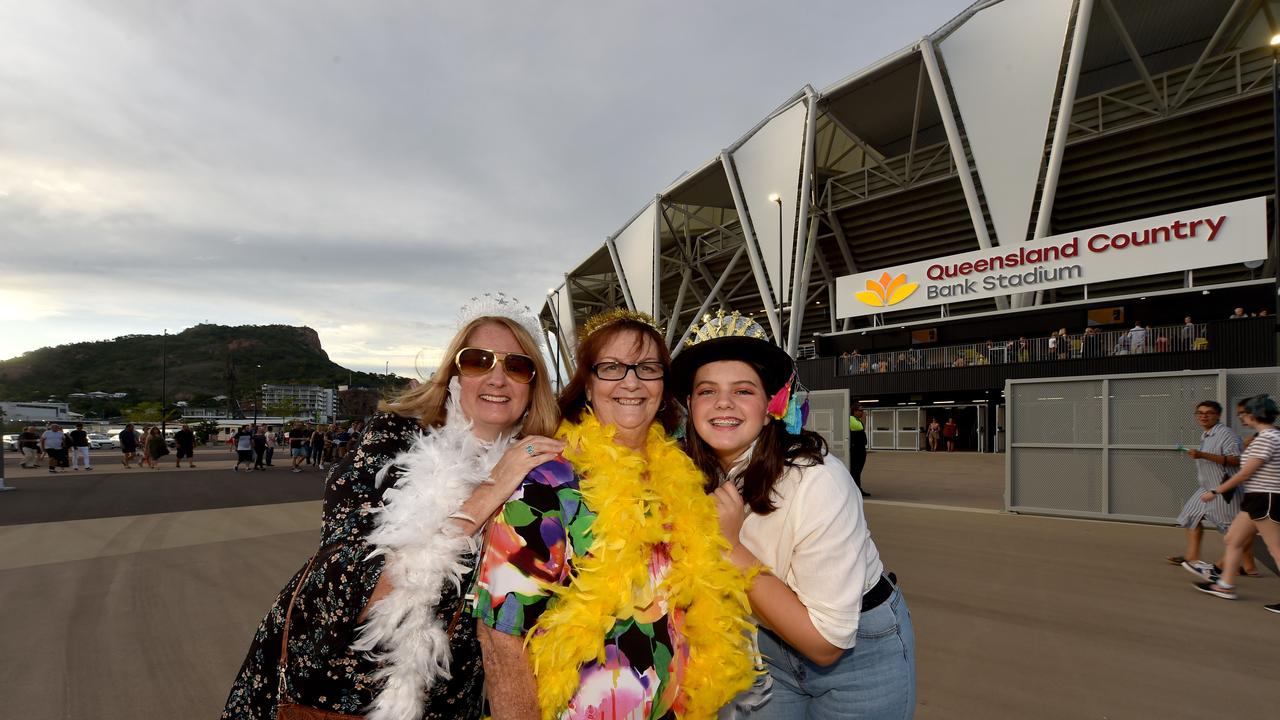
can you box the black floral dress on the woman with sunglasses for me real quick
[221,414,484,720]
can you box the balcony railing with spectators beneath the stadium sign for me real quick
[836,323,1210,375]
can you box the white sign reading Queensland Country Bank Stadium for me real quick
[836,197,1267,318]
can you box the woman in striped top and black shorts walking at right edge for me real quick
[1196,395,1280,612]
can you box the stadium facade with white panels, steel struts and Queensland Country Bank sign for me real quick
[541,0,1280,450]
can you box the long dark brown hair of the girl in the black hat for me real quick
[685,363,827,515]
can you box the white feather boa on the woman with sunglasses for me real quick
[351,379,511,720]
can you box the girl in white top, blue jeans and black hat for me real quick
[672,313,915,719]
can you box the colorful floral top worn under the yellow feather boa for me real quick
[475,460,689,720]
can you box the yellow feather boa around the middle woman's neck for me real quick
[527,410,755,720]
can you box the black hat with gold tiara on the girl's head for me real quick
[671,311,795,398]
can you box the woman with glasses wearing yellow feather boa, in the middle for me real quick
[476,310,754,720]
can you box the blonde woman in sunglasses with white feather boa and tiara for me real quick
[223,295,563,720]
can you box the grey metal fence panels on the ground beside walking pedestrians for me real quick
[1005,368,1280,523]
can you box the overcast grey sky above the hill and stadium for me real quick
[0,0,970,375]
